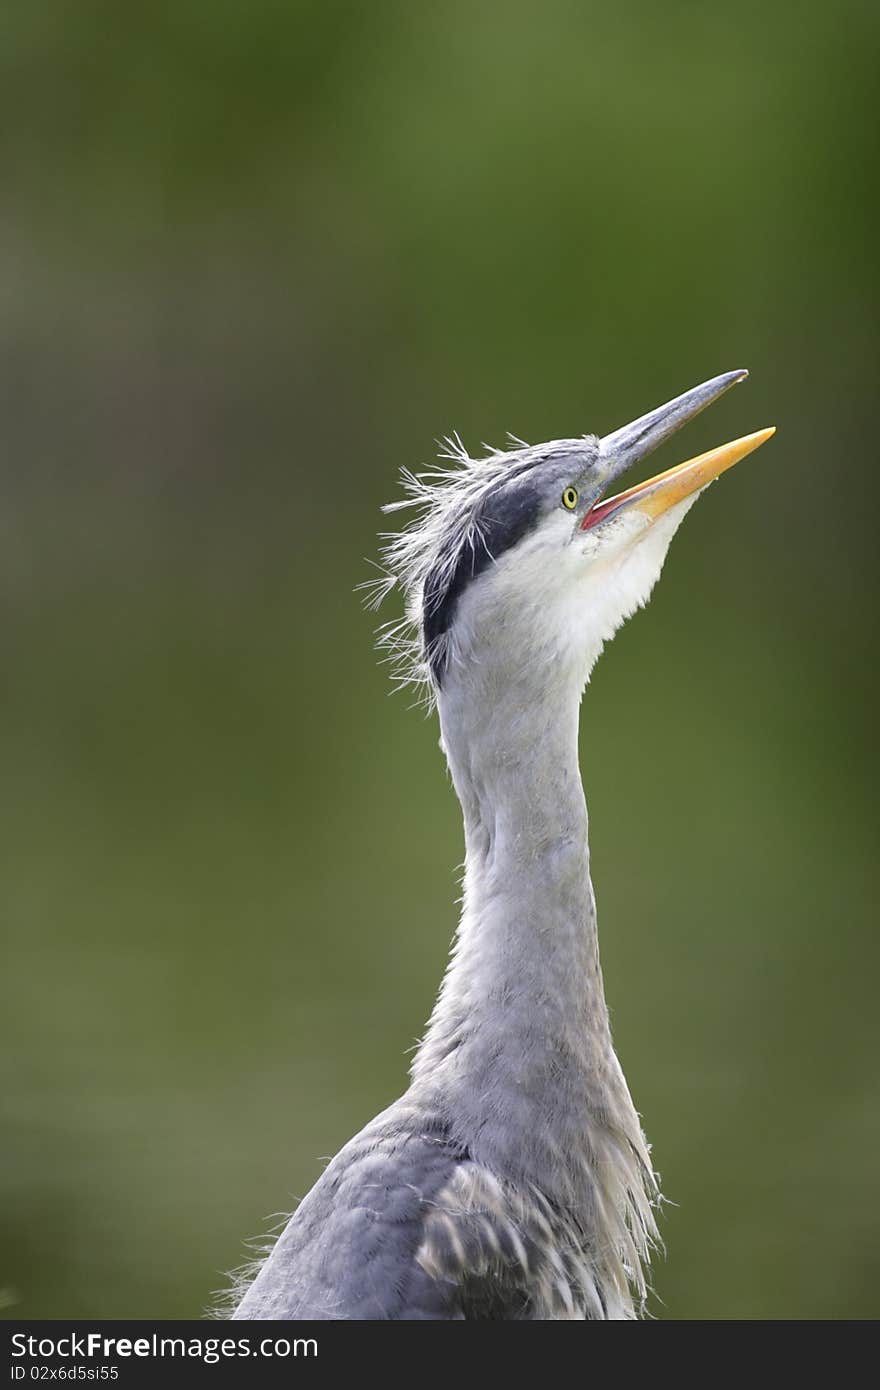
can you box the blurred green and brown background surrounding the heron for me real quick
[0,0,880,1318]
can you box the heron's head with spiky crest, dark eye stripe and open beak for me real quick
[375,371,773,691]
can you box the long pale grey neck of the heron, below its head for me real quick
[413,673,641,1186]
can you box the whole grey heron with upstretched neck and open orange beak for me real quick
[232,371,773,1319]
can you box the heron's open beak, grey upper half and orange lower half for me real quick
[581,371,776,531]
